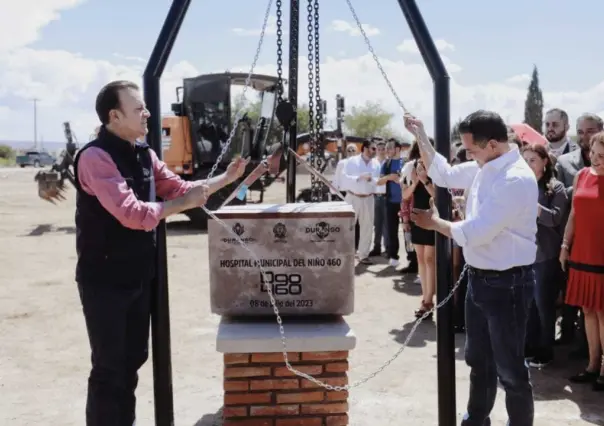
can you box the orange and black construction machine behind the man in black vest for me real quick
[162,72,286,228]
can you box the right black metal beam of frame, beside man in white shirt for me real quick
[398,0,457,426]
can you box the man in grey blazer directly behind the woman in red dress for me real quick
[556,113,604,357]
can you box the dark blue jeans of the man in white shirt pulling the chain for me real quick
[462,265,535,426]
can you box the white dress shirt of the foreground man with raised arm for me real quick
[428,149,539,271]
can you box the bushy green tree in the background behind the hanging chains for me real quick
[344,101,397,138]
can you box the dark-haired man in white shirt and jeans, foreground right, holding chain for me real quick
[405,111,538,426]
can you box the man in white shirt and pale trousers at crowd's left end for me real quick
[339,141,381,265]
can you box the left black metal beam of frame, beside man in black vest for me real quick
[143,0,191,426]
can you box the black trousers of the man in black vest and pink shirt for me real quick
[78,281,150,426]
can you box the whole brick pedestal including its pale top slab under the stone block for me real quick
[218,318,356,426]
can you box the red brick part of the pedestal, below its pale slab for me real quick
[224,351,348,426]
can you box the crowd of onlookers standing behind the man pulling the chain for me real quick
[333,108,604,391]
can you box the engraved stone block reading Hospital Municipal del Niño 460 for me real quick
[208,202,355,316]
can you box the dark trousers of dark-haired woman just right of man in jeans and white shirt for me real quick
[527,259,562,358]
